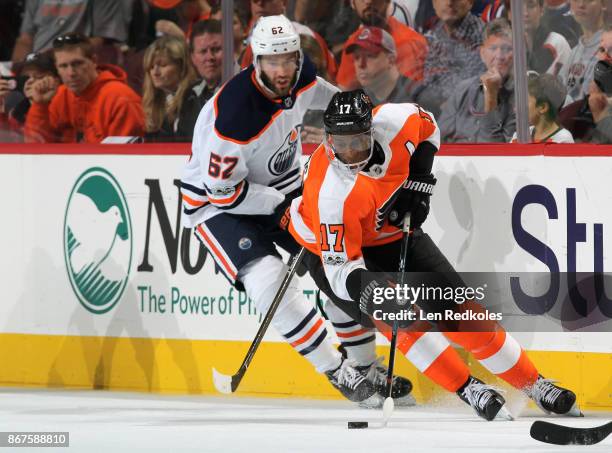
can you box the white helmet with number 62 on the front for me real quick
[251,15,300,61]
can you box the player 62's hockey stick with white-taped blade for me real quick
[213,247,306,394]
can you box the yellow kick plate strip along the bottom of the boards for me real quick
[0,334,612,410]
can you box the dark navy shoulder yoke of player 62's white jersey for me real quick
[214,57,316,144]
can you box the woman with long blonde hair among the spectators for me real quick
[142,36,201,141]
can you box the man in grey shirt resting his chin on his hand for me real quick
[438,19,516,143]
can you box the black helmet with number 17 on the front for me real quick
[323,89,373,135]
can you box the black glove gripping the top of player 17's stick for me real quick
[389,173,436,228]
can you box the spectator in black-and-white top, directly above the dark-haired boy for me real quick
[510,0,572,75]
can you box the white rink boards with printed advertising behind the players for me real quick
[0,154,612,352]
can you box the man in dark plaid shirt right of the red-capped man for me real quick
[418,0,485,117]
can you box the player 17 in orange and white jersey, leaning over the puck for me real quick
[289,90,579,420]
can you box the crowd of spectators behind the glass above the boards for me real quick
[0,0,612,143]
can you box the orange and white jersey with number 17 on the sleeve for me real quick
[289,104,440,300]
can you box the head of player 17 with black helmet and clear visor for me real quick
[323,90,373,175]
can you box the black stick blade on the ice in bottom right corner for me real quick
[529,420,612,445]
